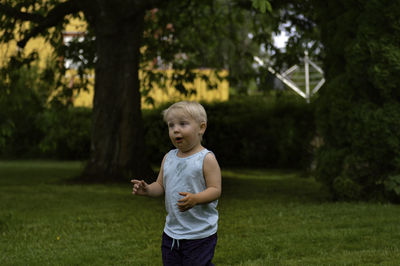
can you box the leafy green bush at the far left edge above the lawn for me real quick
[0,59,45,158]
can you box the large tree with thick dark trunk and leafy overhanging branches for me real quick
[0,0,269,183]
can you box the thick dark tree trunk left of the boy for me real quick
[83,8,153,181]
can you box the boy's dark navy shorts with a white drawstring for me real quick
[161,233,217,266]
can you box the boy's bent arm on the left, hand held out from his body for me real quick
[131,156,165,197]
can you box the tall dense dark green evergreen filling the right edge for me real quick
[315,0,400,200]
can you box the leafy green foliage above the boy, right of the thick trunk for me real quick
[141,0,279,94]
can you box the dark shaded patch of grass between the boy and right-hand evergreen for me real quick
[222,169,331,203]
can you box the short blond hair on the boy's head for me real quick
[162,101,207,123]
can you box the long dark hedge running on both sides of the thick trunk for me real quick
[0,97,315,168]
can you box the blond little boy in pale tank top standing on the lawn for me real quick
[131,101,221,265]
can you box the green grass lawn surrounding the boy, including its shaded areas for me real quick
[0,161,400,265]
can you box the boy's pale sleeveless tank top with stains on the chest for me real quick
[163,149,218,240]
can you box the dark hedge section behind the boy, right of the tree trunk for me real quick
[144,97,315,168]
